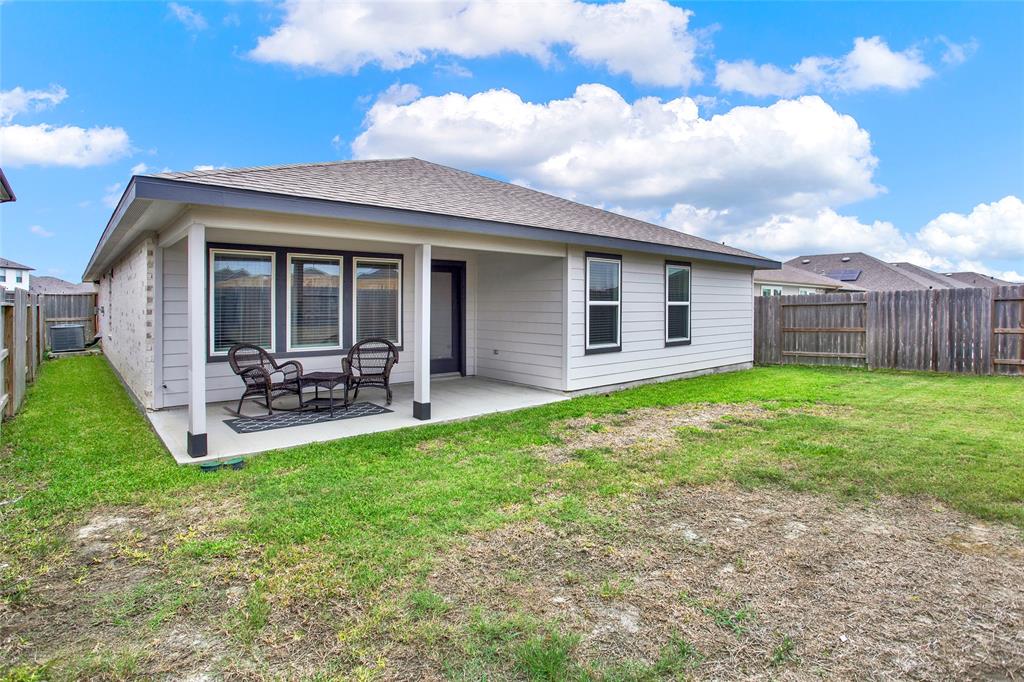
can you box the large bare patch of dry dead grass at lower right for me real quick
[419,485,1024,679]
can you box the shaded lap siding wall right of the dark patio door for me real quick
[476,254,564,389]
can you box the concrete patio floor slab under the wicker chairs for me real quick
[148,376,567,464]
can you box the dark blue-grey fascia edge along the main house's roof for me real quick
[83,176,782,281]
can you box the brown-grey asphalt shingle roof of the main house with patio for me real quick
[154,159,761,258]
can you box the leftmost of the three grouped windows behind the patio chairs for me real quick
[210,251,274,353]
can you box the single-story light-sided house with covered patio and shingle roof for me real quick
[83,159,779,461]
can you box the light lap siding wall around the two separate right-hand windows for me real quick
[568,250,754,390]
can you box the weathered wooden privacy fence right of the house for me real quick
[754,286,1024,375]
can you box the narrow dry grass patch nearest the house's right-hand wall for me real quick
[535,402,838,464]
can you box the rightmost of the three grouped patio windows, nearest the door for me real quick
[352,258,401,345]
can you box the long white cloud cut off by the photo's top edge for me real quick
[250,0,701,86]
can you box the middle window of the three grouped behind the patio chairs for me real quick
[288,255,342,350]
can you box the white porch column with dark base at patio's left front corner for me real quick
[186,222,207,457]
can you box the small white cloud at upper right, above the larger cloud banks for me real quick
[715,36,933,97]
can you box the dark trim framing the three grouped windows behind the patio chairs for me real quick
[206,242,406,367]
